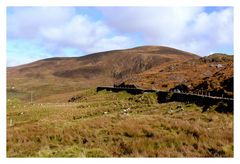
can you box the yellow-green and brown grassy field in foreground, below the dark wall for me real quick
[7,89,233,157]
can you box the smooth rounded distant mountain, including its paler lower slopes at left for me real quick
[7,46,199,101]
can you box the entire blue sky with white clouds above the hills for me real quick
[7,7,233,66]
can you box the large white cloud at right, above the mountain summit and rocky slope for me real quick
[100,7,233,55]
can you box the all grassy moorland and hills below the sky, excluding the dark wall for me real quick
[7,46,234,157]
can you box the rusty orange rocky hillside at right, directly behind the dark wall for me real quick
[127,54,233,97]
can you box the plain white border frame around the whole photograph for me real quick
[0,0,240,164]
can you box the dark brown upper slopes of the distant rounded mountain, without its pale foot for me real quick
[8,46,197,79]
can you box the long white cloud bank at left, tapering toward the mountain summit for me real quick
[8,7,132,53]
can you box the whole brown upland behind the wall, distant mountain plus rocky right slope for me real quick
[7,46,233,101]
